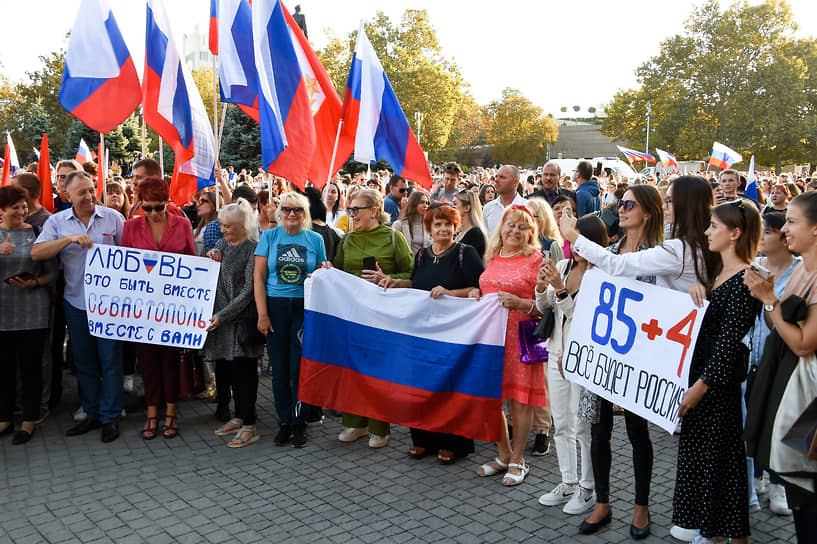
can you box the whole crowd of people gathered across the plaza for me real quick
[0,155,817,543]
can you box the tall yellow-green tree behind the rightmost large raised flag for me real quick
[318,9,465,154]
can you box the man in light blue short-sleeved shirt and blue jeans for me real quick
[31,170,125,442]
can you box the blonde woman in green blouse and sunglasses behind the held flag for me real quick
[333,189,413,448]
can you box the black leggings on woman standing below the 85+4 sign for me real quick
[590,398,653,506]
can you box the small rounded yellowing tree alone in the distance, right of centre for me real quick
[487,88,559,166]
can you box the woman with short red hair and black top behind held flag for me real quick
[379,202,483,465]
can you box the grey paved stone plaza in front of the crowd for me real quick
[0,374,794,544]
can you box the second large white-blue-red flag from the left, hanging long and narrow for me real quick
[142,0,216,203]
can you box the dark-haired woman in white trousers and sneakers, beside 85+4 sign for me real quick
[536,215,607,514]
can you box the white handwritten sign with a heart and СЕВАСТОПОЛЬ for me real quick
[85,244,220,349]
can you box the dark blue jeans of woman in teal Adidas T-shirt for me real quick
[267,297,306,425]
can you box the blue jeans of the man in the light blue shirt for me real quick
[63,300,125,423]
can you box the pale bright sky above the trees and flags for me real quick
[0,0,817,117]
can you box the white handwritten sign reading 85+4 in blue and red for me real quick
[562,268,709,433]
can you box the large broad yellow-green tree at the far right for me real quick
[602,0,817,169]
